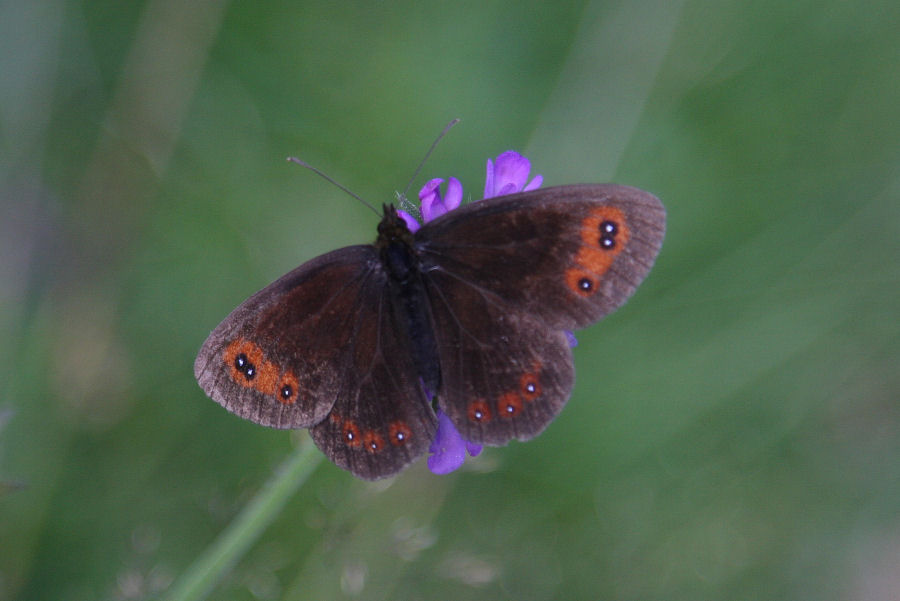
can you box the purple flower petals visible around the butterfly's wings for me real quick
[397,150,544,474]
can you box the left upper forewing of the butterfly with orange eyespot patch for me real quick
[194,246,378,428]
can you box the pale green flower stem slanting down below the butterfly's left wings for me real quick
[164,439,322,601]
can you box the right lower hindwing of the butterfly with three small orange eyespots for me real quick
[426,270,575,445]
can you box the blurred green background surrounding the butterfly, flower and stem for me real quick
[0,0,900,601]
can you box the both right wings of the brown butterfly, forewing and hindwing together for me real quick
[415,185,665,444]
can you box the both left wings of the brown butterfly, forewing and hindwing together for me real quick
[194,246,437,479]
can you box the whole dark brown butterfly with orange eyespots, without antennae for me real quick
[194,168,665,479]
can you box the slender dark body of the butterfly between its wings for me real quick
[375,205,441,393]
